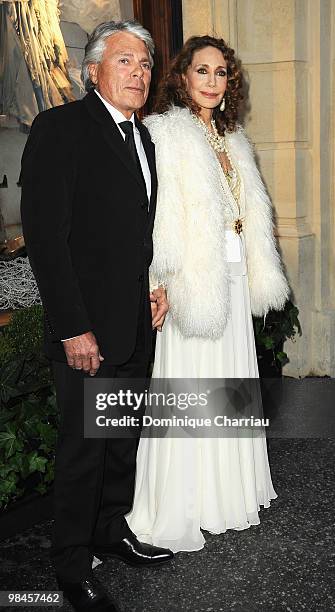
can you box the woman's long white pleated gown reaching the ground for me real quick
[126,157,277,552]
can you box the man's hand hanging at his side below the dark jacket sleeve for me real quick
[63,332,104,376]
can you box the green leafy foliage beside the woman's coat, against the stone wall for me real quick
[254,300,302,370]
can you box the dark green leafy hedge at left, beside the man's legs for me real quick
[0,306,58,508]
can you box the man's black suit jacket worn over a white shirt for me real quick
[21,90,157,364]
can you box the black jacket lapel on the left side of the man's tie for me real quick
[83,89,145,198]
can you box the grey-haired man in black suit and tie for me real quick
[22,22,173,610]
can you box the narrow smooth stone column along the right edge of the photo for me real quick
[309,0,335,376]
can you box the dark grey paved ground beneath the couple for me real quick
[0,439,335,612]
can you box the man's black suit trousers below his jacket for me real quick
[52,290,152,582]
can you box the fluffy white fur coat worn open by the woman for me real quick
[144,107,289,339]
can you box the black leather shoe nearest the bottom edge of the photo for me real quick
[58,576,120,612]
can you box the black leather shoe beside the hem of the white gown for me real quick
[94,533,174,567]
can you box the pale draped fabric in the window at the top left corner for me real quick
[0,0,75,126]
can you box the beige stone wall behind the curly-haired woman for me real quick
[183,0,335,376]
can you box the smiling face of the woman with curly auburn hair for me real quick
[183,47,227,109]
